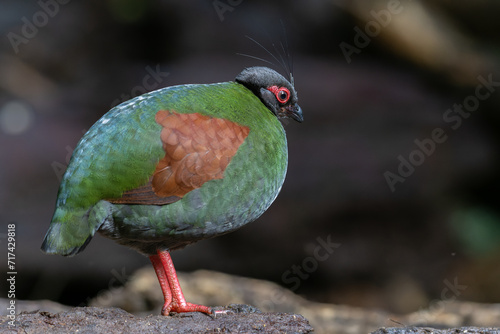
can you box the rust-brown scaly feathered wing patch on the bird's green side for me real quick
[109,110,250,205]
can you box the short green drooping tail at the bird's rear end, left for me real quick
[41,207,96,256]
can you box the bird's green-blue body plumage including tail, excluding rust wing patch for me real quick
[42,82,287,255]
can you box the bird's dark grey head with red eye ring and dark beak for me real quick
[236,66,304,122]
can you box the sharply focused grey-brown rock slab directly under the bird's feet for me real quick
[0,305,312,333]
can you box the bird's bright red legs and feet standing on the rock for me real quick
[149,250,212,315]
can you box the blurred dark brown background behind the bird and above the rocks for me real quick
[0,0,500,312]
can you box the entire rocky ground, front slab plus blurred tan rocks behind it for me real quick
[0,267,500,334]
